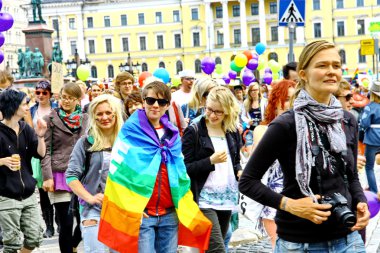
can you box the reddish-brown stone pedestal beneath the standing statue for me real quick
[22,22,54,77]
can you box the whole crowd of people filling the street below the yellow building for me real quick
[0,40,380,253]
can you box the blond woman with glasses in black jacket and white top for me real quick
[182,87,242,253]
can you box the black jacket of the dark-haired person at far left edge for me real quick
[0,121,42,200]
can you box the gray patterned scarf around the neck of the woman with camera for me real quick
[293,90,347,200]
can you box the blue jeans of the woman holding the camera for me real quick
[274,231,366,253]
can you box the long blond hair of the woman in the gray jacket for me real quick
[88,94,124,151]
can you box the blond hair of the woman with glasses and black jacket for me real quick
[206,86,239,132]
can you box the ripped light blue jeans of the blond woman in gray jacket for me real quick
[80,209,115,253]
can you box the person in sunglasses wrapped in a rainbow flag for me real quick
[99,81,212,253]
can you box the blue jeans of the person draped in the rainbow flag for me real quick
[139,211,178,253]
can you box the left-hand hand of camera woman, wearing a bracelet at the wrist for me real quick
[281,195,331,224]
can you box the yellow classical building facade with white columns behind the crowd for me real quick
[29,0,380,78]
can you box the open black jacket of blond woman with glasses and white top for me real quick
[182,117,242,203]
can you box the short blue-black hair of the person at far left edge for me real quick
[0,89,26,120]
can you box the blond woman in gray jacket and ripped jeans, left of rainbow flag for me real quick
[65,94,123,252]
